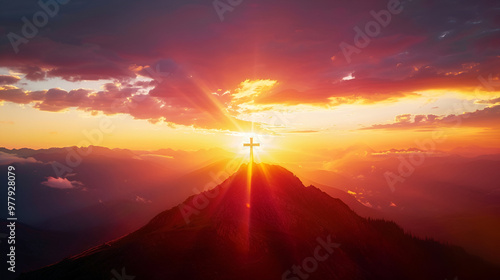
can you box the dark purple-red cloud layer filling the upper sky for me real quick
[0,0,500,129]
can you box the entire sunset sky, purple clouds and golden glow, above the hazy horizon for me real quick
[0,0,500,158]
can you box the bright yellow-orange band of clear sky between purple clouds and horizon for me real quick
[0,75,499,160]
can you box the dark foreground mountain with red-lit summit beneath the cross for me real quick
[19,164,500,280]
